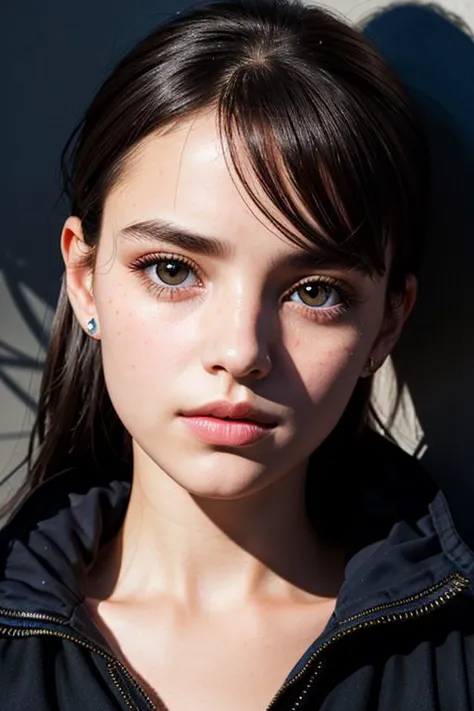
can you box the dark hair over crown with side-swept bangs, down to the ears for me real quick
[68,0,429,292]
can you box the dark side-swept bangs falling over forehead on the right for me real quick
[218,52,414,278]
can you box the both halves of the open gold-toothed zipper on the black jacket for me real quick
[0,572,470,711]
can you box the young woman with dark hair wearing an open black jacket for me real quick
[0,0,474,711]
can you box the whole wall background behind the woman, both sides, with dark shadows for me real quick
[0,0,474,538]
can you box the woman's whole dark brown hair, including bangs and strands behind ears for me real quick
[2,0,426,524]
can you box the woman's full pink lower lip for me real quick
[182,417,274,447]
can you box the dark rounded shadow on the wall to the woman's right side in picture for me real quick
[365,4,474,545]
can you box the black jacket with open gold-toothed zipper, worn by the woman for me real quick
[0,436,474,711]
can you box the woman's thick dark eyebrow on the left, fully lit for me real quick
[119,219,233,259]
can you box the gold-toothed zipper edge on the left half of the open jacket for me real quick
[0,624,157,711]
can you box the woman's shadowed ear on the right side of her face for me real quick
[362,274,418,377]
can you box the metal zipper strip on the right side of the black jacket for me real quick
[266,571,470,711]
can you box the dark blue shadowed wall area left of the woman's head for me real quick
[0,0,190,496]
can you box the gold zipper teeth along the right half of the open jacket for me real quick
[266,572,470,711]
